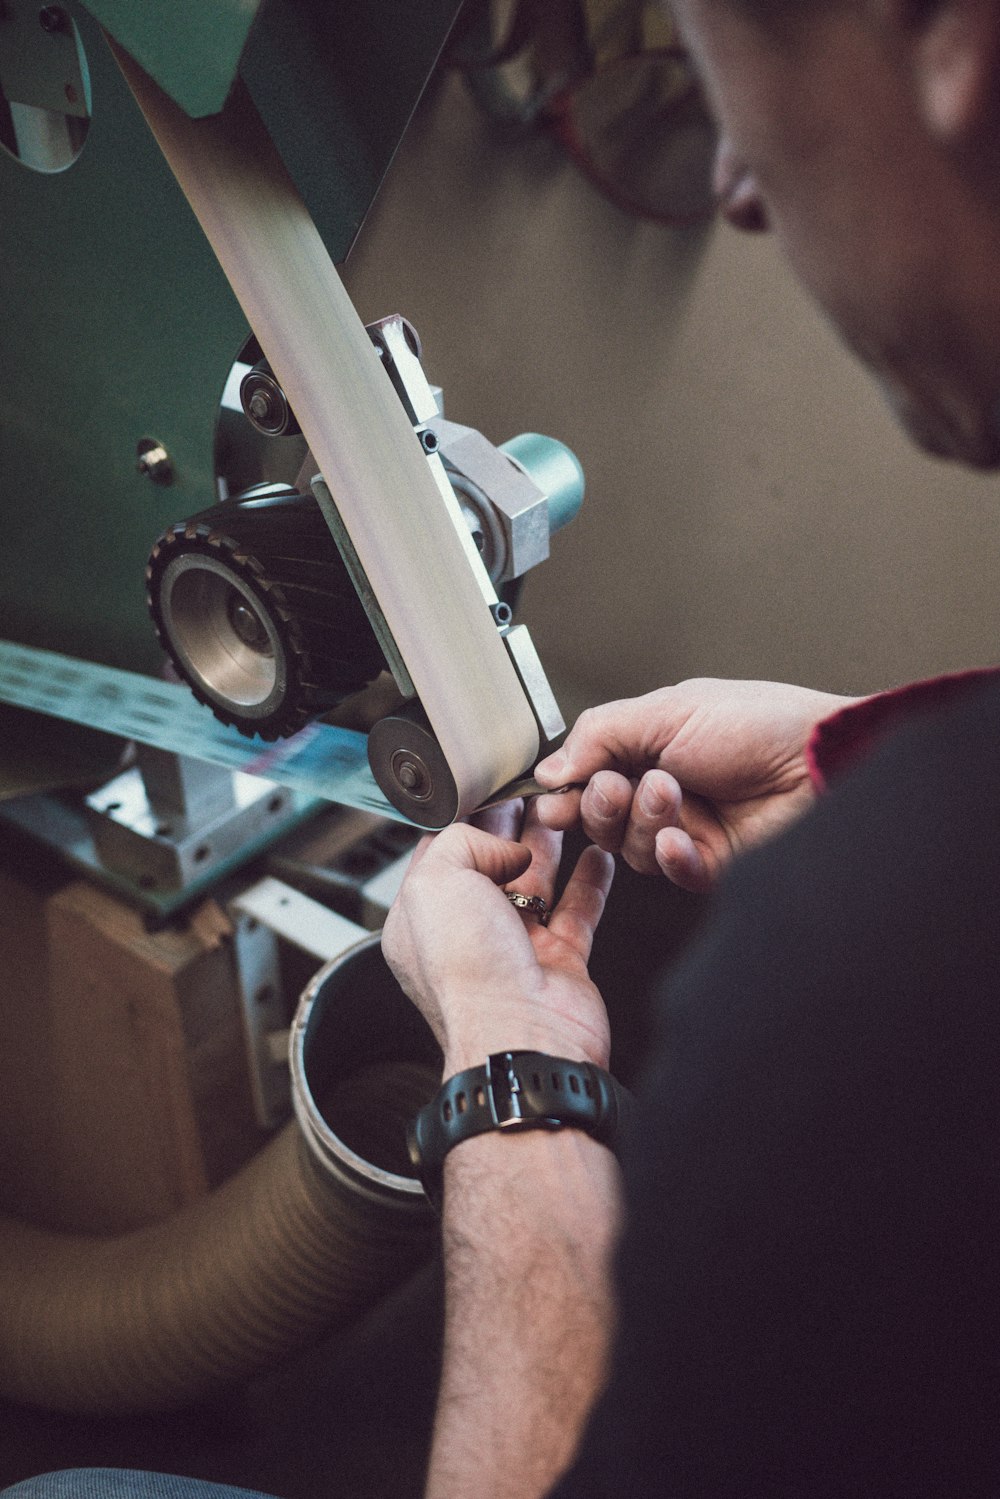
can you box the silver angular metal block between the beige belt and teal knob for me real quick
[430,417,549,585]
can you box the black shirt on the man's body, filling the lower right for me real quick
[556,687,1000,1499]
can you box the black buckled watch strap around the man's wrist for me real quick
[406,1051,631,1205]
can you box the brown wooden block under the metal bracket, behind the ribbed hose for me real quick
[0,881,261,1234]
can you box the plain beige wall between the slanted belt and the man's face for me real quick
[346,70,1000,712]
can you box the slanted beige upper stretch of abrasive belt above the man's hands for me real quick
[112,43,538,814]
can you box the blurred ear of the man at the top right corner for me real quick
[883,0,1000,151]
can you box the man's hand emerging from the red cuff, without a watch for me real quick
[535,678,853,890]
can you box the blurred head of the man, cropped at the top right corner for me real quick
[673,0,1000,465]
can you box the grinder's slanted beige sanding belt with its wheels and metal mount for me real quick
[0,0,582,827]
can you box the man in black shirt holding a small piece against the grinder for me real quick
[385,0,1000,1499]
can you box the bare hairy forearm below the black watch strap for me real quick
[427,1129,619,1499]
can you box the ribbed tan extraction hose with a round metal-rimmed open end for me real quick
[0,937,439,1415]
